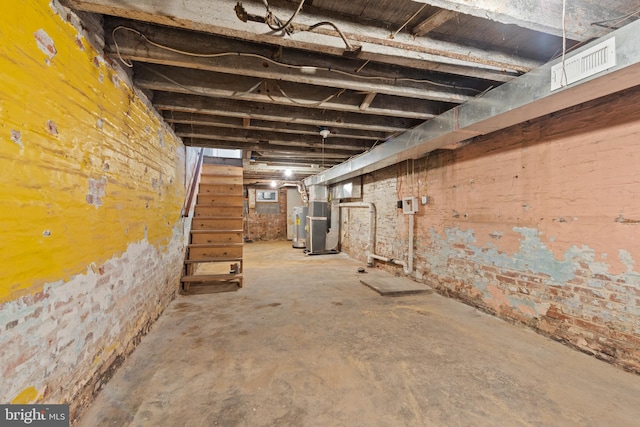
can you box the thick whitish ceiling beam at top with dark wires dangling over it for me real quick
[63,0,538,75]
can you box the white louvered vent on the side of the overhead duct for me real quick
[551,37,616,91]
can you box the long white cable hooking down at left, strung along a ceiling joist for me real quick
[111,25,481,93]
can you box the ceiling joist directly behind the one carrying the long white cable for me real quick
[134,64,442,120]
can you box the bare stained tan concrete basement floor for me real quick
[79,242,640,427]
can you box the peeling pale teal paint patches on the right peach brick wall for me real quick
[418,227,640,322]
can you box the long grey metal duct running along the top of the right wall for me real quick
[305,21,640,185]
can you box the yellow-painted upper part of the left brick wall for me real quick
[0,0,184,303]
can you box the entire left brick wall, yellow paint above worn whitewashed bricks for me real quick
[0,0,194,417]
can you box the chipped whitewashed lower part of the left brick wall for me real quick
[0,234,184,418]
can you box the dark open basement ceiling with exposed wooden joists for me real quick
[63,0,640,183]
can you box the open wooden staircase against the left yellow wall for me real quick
[182,162,243,293]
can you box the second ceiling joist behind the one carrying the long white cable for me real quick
[153,92,421,132]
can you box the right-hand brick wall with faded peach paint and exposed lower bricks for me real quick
[343,88,640,373]
